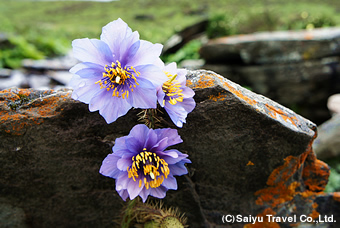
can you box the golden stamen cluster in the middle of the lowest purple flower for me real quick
[127,148,170,189]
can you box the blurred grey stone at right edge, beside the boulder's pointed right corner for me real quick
[313,114,340,159]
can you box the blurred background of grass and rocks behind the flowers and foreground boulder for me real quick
[0,0,340,192]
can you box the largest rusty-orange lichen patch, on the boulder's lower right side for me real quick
[246,134,328,227]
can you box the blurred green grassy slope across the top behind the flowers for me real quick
[0,0,340,68]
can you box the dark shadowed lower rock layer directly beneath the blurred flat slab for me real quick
[203,58,340,124]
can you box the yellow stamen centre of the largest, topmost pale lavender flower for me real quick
[95,60,140,99]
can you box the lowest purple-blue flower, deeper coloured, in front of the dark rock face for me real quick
[99,124,191,202]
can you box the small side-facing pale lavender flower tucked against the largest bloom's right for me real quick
[157,63,196,127]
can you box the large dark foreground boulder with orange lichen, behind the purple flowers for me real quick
[0,70,340,227]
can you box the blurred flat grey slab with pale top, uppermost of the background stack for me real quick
[200,27,340,64]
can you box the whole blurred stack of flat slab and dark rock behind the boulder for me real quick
[200,27,340,125]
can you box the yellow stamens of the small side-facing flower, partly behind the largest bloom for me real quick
[162,72,183,105]
